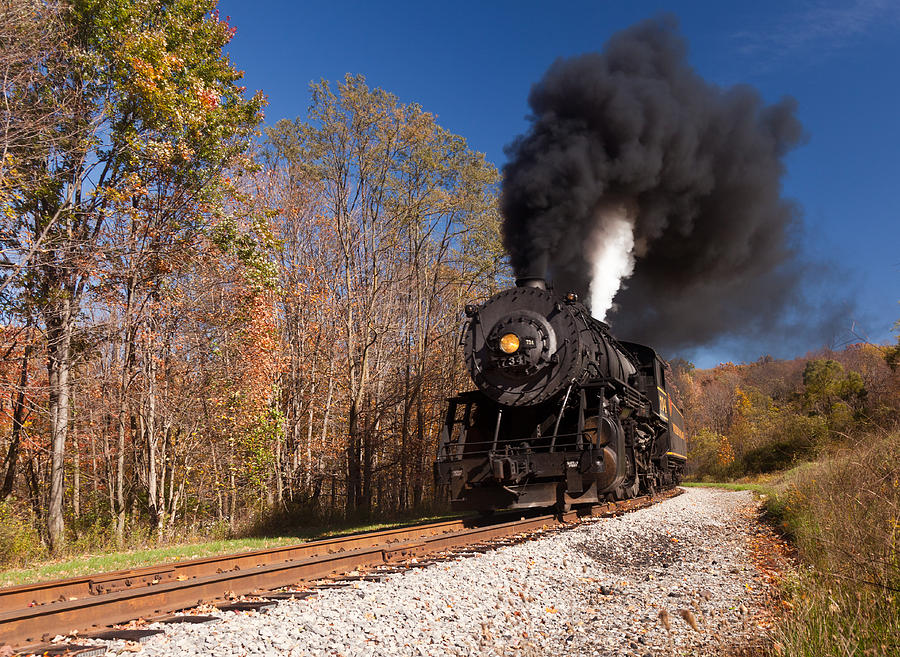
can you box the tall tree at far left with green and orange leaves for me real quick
[7,0,262,546]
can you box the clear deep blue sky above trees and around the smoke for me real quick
[219,0,900,366]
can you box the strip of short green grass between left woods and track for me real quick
[0,514,459,587]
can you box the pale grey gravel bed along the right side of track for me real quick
[93,488,766,657]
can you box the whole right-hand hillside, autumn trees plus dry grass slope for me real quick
[673,344,900,657]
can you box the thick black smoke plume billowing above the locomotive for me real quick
[502,17,848,353]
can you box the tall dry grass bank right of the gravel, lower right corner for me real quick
[768,432,900,657]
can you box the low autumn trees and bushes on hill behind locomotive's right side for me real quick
[684,343,900,481]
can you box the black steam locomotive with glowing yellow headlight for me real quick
[435,278,687,513]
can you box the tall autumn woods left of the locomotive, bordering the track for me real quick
[0,0,505,560]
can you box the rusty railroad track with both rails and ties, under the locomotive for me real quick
[0,489,678,657]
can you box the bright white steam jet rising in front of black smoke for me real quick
[587,203,635,320]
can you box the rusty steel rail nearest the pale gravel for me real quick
[0,496,667,652]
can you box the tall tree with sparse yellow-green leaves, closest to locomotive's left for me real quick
[268,75,501,511]
